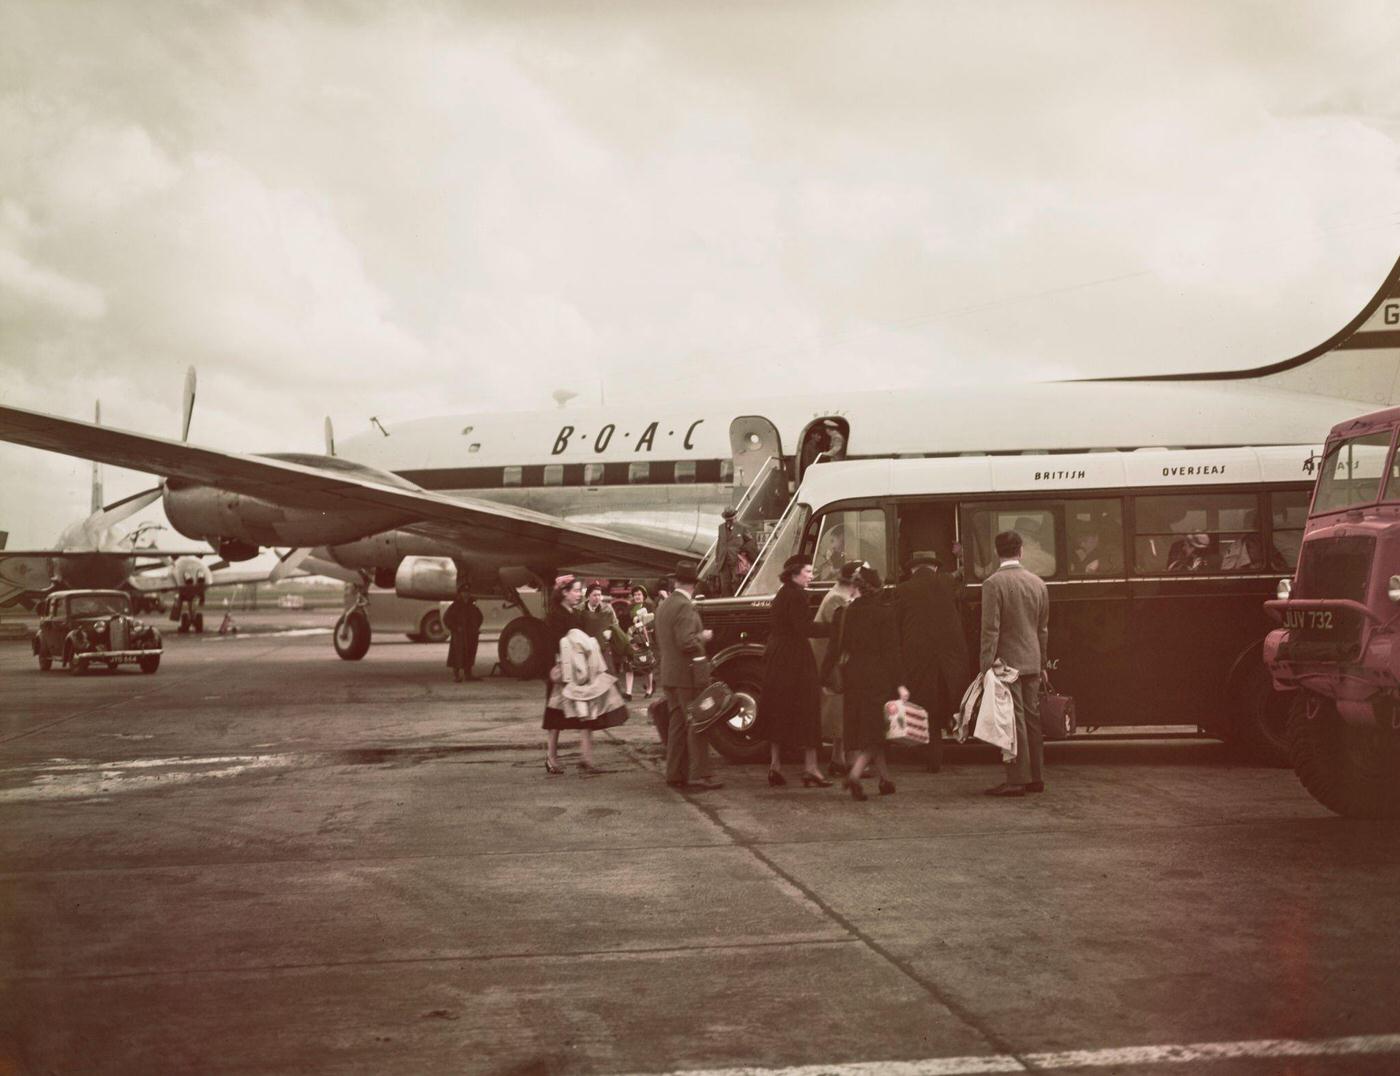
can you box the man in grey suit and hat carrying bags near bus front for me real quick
[654,561,724,792]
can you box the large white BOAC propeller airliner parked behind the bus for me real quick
[0,249,1400,677]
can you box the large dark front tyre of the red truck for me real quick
[1288,691,1400,819]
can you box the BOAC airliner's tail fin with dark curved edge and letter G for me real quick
[1095,251,1400,407]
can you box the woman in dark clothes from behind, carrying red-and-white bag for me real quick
[832,568,909,799]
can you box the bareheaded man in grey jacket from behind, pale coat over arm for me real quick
[980,530,1050,796]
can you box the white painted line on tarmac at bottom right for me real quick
[641,1034,1400,1076]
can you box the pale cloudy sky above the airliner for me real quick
[0,0,1400,548]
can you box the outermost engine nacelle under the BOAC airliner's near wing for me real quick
[162,479,406,546]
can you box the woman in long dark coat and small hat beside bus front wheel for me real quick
[753,555,832,788]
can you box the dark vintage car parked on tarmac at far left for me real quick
[31,590,162,673]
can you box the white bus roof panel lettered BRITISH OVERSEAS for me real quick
[797,444,1316,509]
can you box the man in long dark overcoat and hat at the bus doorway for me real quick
[895,551,972,774]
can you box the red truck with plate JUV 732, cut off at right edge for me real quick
[1264,407,1400,819]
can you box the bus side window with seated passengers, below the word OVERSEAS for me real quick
[1133,493,1266,575]
